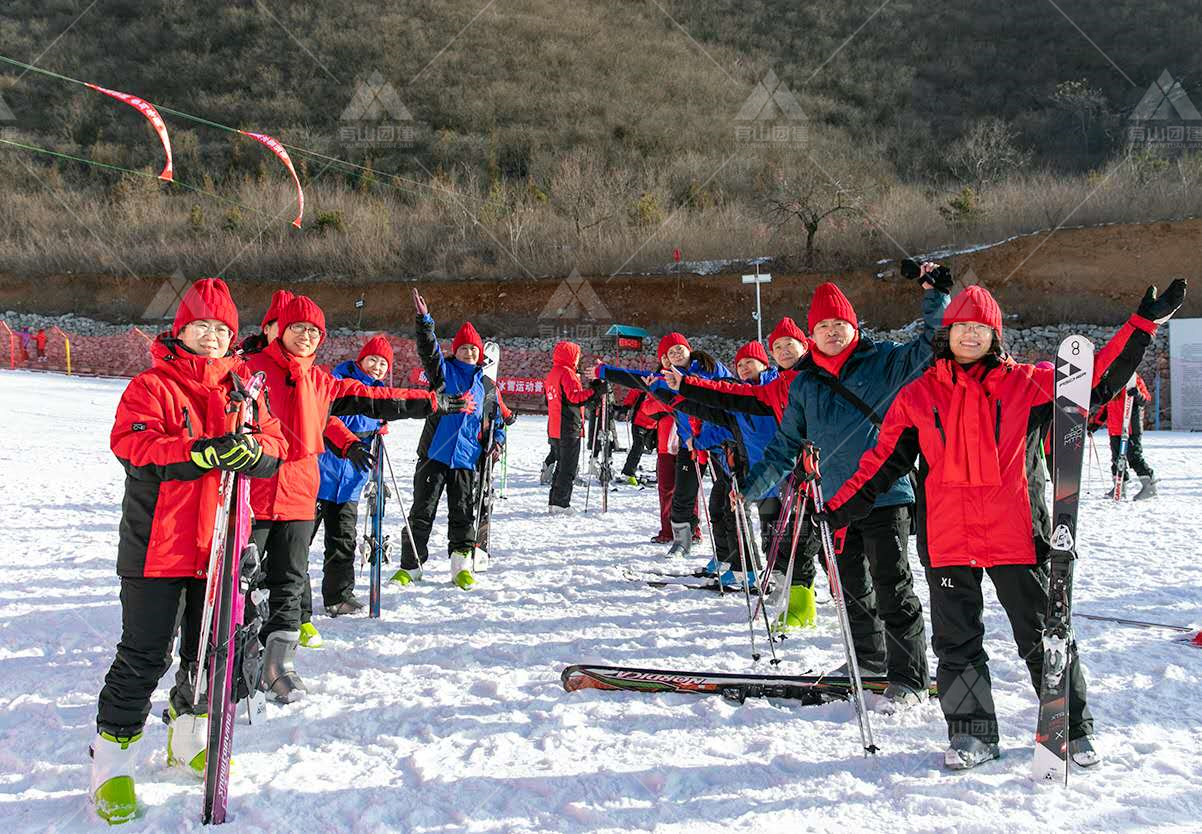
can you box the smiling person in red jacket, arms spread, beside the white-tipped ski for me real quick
[827,280,1185,769]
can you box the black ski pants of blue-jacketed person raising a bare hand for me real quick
[400,458,476,568]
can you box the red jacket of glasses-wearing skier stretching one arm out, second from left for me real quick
[246,339,438,523]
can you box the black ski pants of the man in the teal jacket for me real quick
[835,505,930,690]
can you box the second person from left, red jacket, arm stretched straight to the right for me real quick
[246,296,475,703]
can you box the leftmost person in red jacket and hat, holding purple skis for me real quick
[91,278,287,822]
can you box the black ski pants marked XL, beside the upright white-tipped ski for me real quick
[927,565,1094,744]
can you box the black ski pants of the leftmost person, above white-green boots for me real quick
[96,577,206,737]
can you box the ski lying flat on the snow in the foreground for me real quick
[560,663,935,705]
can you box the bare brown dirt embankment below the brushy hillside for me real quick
[0,220,1202,336]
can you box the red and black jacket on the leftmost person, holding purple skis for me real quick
[109,336,287,579]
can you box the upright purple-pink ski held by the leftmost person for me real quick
[197,373,266,826]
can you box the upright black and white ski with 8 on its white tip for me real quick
[1031,335,1094,784]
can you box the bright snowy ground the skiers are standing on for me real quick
[0,371,1202,834]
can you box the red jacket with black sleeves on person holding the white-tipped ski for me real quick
[827,316,1156,567]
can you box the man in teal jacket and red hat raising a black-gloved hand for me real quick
[697,264,952,705]
